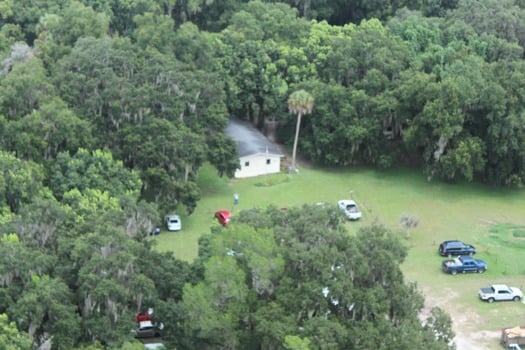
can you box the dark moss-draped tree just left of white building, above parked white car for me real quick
[119,117,205,213]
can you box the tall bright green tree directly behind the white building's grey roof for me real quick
[221,1,309,130]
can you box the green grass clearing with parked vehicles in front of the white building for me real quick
[149,163,525,350]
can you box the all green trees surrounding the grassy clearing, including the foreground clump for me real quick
[0,0,525,349]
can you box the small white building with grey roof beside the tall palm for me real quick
[225,118,283,178]
